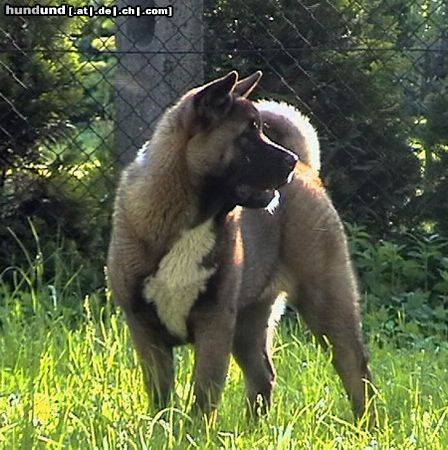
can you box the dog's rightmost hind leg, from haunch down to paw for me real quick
[280,192,375,423]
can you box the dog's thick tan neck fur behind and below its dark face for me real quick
[123,111,236,246]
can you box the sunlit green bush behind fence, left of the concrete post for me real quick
[0,7,114,288]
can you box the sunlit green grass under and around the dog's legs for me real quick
[0,284,448,449]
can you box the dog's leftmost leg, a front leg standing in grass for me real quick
[127,311,174,409]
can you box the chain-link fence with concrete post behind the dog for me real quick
[0,0,448,284]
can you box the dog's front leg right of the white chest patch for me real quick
[189,214,243,413]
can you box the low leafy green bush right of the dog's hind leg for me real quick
[346,224,448,340]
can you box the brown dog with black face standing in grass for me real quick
[107,71,372,417]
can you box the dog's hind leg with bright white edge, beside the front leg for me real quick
[233,302,275,416]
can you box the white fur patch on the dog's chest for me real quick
[143,220,216,339]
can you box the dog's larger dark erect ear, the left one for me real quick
[194,70,238,117]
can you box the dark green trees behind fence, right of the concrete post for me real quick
[206,0,448,235]
